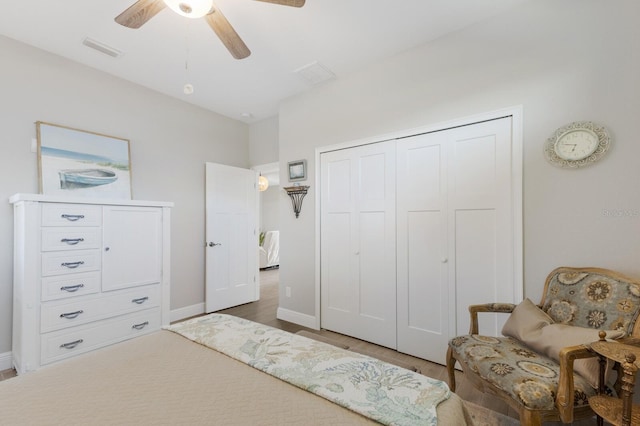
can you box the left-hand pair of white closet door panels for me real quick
[320,141,396,348]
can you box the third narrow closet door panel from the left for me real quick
[397,132,450,363]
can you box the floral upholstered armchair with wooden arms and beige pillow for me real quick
[447,267,640,426]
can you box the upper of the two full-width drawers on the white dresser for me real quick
[40,285,161,333]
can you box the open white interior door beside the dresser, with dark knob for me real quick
[205,163,260,312]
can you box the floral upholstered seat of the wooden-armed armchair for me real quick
[449,335,596,410]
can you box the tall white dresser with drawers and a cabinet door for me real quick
[9,194,173,374]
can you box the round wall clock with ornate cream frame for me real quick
[544,121,611,168]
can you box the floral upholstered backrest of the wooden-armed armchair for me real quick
[542,272,640,335]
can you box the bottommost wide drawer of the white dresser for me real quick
[40,308,160,364]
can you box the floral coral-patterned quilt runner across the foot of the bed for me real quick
[167,314,451,425]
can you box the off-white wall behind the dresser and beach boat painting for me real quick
[0,37,249,355]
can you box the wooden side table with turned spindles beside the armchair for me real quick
[589,332,640,426]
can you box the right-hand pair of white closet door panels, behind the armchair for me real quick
[397,117,514,364]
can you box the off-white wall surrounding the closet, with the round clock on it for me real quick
[279,0,640,316]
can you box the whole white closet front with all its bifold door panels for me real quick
[320,117,521,363]
